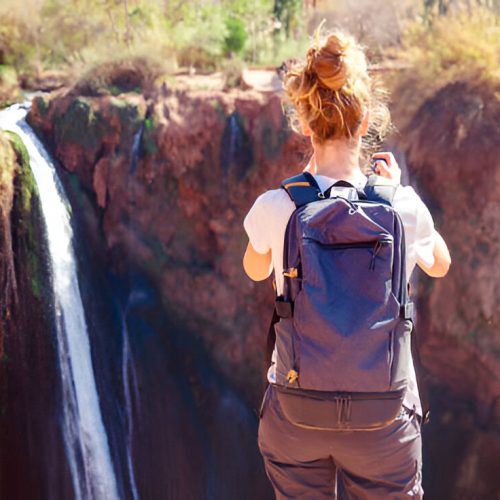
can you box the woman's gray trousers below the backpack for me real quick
[259,384,423,500]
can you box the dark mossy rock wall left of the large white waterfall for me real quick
[0,131,72,498]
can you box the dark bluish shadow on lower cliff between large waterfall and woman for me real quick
[62,165,272,500]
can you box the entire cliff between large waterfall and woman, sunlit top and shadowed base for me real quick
[29,91,308,499]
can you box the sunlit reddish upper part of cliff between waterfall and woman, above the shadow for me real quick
[29,90,308,405]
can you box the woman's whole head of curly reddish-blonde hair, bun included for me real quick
[284,23,390,151]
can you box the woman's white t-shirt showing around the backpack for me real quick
[243,170,434,414]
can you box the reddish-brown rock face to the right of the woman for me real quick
[402,82,500,498]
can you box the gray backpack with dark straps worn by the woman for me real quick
[268,172,428,430]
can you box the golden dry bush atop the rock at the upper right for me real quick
[388,8,500,126]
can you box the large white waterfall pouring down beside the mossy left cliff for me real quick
[0,104,119,500]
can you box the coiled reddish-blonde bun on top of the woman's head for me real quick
[307,35,347,91]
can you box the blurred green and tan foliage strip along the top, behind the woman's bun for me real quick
[0,0,500,86]
